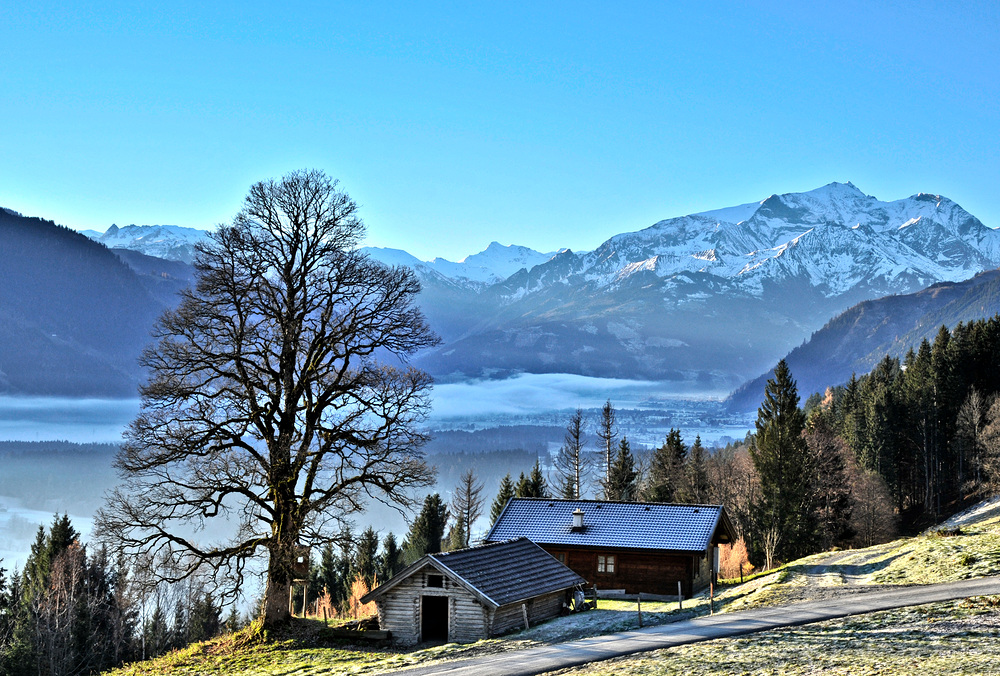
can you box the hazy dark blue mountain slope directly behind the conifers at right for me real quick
[728,270,1000,411]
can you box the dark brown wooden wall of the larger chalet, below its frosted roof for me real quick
[541,545,711,596]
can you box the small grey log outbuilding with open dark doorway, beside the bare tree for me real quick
[361,538,586,645]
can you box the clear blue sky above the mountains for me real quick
[0,0,1000,260]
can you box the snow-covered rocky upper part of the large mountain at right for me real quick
[511,183,1000,303]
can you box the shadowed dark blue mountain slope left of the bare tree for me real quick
[0,210,164,396]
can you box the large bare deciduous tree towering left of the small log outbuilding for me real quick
[98,171,437,625]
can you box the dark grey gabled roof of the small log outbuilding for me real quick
[361,538,586,608]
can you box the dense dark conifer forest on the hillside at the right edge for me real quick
[807,317,1000,530]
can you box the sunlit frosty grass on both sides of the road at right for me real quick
[560,509,1000,676]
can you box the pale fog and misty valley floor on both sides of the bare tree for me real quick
[0,374,753,570]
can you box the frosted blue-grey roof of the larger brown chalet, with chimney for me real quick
[486,498,733,552]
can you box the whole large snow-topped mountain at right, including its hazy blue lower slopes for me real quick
[398,183,1000,389]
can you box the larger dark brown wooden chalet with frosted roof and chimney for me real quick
[485,498,735,596]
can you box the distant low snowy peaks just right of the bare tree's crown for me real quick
[362,242,555,290]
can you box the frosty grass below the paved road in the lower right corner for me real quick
[559,597,1000,676]
